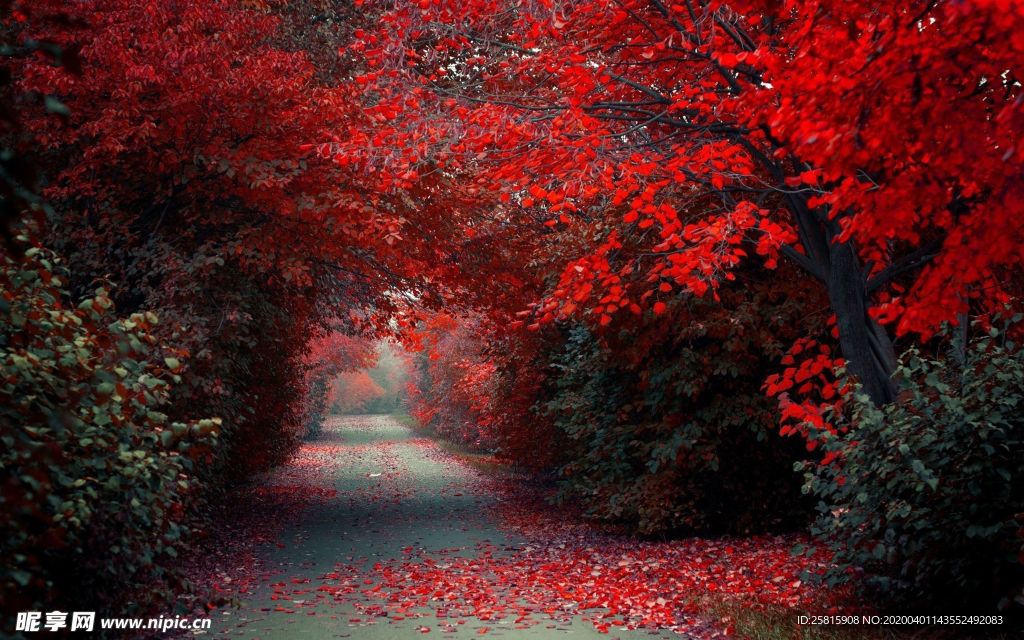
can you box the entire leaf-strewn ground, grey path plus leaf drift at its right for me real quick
[174,417,856,638]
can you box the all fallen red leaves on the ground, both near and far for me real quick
[190,418,853,637]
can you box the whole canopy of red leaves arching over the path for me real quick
[8,0,1024,624]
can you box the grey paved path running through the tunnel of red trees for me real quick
[210,416,670,640]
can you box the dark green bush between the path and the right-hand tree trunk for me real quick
[544,274,823,534]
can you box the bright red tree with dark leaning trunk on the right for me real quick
[346,0,1024,402]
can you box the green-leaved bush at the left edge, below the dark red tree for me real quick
[0,243,219,632]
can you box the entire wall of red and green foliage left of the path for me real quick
[0,0,432,632]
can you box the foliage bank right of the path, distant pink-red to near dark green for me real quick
[405,262,828,532]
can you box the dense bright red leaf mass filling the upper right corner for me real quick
[741,0,1024,334]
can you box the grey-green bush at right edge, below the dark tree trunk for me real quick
[798,317,1024,612]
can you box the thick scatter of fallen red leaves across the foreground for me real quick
[321,532,823,633]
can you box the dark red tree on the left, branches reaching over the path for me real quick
[14,0,548,473]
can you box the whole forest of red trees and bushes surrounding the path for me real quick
[0,0,1024,637]
